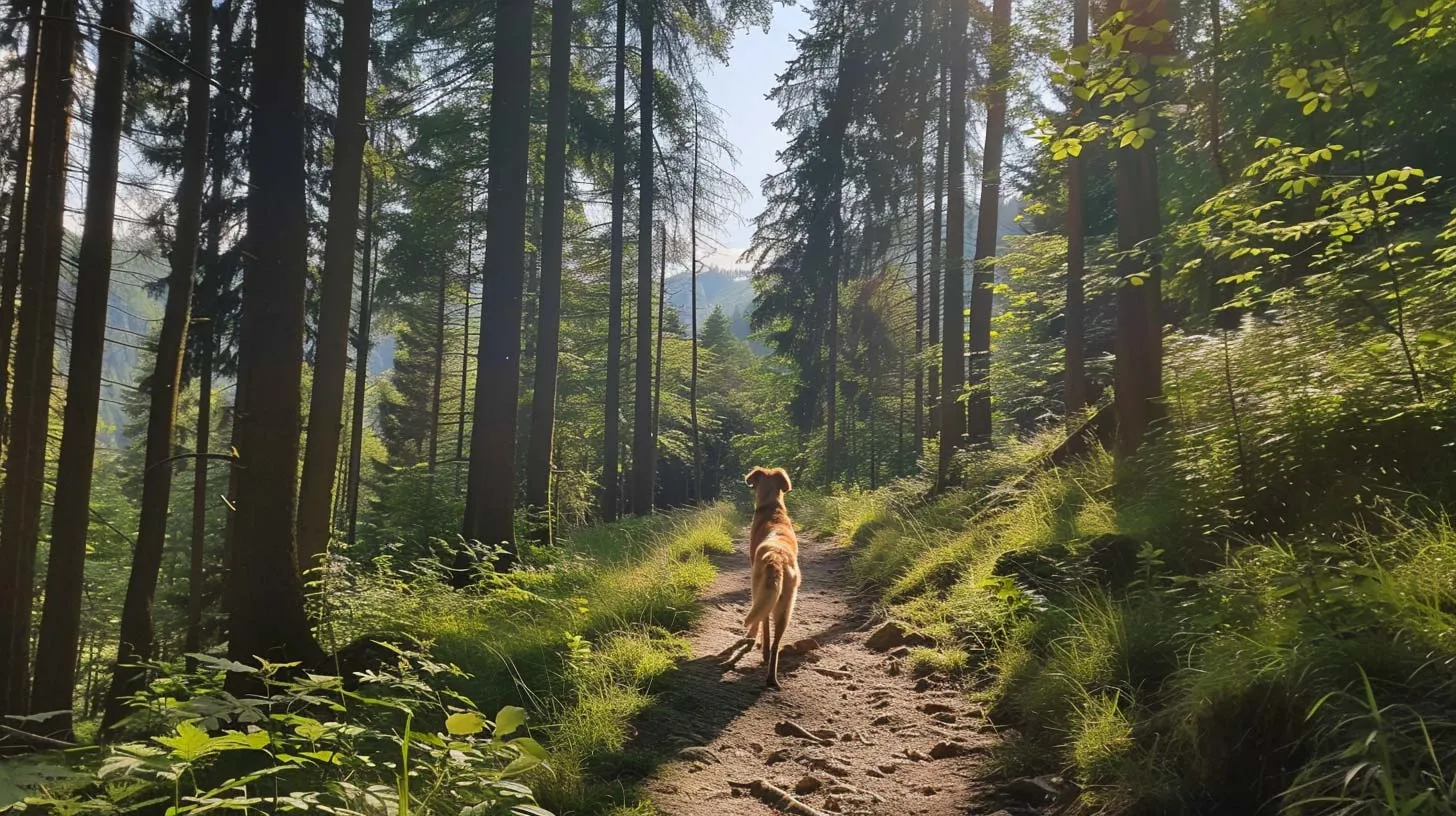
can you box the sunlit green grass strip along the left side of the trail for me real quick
[336,504,738,815]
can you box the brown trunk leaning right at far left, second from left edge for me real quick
[0,0,76,715]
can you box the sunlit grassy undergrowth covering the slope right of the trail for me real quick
[827,310,1456,815]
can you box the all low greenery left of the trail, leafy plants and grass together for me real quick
[0,504,737,816]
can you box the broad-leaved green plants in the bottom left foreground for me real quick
[0,650,549,816]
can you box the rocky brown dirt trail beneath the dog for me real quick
[641,539,1031,816]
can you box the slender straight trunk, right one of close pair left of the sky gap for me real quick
[632,3,657,516]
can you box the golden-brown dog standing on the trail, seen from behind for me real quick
[744,468,802,689]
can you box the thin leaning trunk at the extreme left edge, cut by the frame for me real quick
[0,0,41,460]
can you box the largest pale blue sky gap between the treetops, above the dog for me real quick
[690,4,810,268]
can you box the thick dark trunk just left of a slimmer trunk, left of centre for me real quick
[454,0,533,574]
